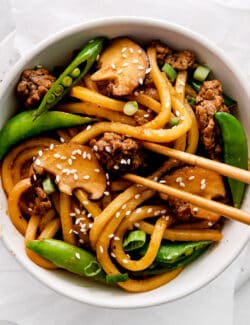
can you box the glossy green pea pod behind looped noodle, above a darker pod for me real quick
[140,241,211,264]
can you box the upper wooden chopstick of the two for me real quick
[142,142,250,184]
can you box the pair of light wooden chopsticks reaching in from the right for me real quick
[124,142,250,225]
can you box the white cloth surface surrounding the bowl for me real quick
[0,0,250,325]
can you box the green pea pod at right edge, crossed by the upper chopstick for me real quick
[214,112,248,208]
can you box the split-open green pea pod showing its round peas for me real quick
[33,36,106,119]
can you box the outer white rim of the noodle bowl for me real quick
[0,16,250,309]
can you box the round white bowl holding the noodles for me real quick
[0,17,250,308]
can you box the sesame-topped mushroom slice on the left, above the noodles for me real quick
[33,143,106,200]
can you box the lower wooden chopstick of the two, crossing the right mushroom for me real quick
[123,174,250,225]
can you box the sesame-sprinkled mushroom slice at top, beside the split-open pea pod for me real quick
[91,38,149,96]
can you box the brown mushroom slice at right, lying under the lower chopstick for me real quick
[161,166,226,222]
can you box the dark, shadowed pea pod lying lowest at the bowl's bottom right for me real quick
[134,242,211,276]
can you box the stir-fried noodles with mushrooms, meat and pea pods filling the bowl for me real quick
[0,37,247,292]
